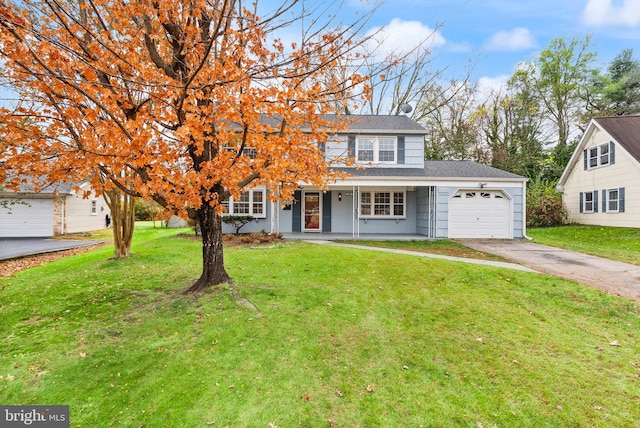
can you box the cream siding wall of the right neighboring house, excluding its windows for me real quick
[563,129,640,227]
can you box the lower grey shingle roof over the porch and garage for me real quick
[334,160,526,180]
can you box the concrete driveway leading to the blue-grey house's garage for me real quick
[458,239,640,301]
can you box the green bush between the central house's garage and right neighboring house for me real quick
[527,180,567,227]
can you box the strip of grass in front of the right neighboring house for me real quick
[527,225,640,265]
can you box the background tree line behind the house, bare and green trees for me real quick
[371,37,640,226]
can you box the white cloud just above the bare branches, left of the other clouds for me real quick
[367,18,446,57]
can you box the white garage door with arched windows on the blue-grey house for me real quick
[449,190,512,239]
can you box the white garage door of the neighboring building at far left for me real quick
[0,199,53,238]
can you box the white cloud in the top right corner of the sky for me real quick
[582,0,640,27]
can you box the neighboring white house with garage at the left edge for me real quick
[0,178,110,238]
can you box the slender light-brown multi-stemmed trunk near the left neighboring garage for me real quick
[104,188,135,259]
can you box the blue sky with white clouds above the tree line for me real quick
[351,0,640,90]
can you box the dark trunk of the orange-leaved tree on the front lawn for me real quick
[186,202,231,293]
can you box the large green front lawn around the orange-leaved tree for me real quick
[0,229,640,427]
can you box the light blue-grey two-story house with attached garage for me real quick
[225,115,526,239]
